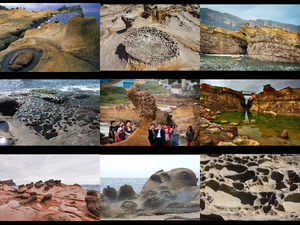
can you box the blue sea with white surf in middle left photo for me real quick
[0,79,100,96]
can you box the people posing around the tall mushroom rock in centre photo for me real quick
[109,120,194,147]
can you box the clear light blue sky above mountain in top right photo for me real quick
[200,4,300,25]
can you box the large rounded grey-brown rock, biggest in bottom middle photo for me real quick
[140,168,197,194]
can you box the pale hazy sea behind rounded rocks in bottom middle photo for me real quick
[100,177,200,194]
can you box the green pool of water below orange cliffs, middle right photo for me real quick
[212,111,300,145]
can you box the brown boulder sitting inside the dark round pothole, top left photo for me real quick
[9,51,33,71]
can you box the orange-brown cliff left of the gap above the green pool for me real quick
[200,83,246,112]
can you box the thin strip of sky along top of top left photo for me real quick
[0,3,100,13]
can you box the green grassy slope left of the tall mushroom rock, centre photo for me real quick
[100,86,130,105]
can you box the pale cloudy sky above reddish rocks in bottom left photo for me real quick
[0,155,100,185]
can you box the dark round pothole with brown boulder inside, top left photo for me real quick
[1,48,42,72]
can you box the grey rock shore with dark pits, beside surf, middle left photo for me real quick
[0,89,100,145]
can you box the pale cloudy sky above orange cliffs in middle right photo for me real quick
[200,79,300,94]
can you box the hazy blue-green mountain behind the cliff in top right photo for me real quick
[200,8,300,32]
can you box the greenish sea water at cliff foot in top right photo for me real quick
[200,54,300,71]
